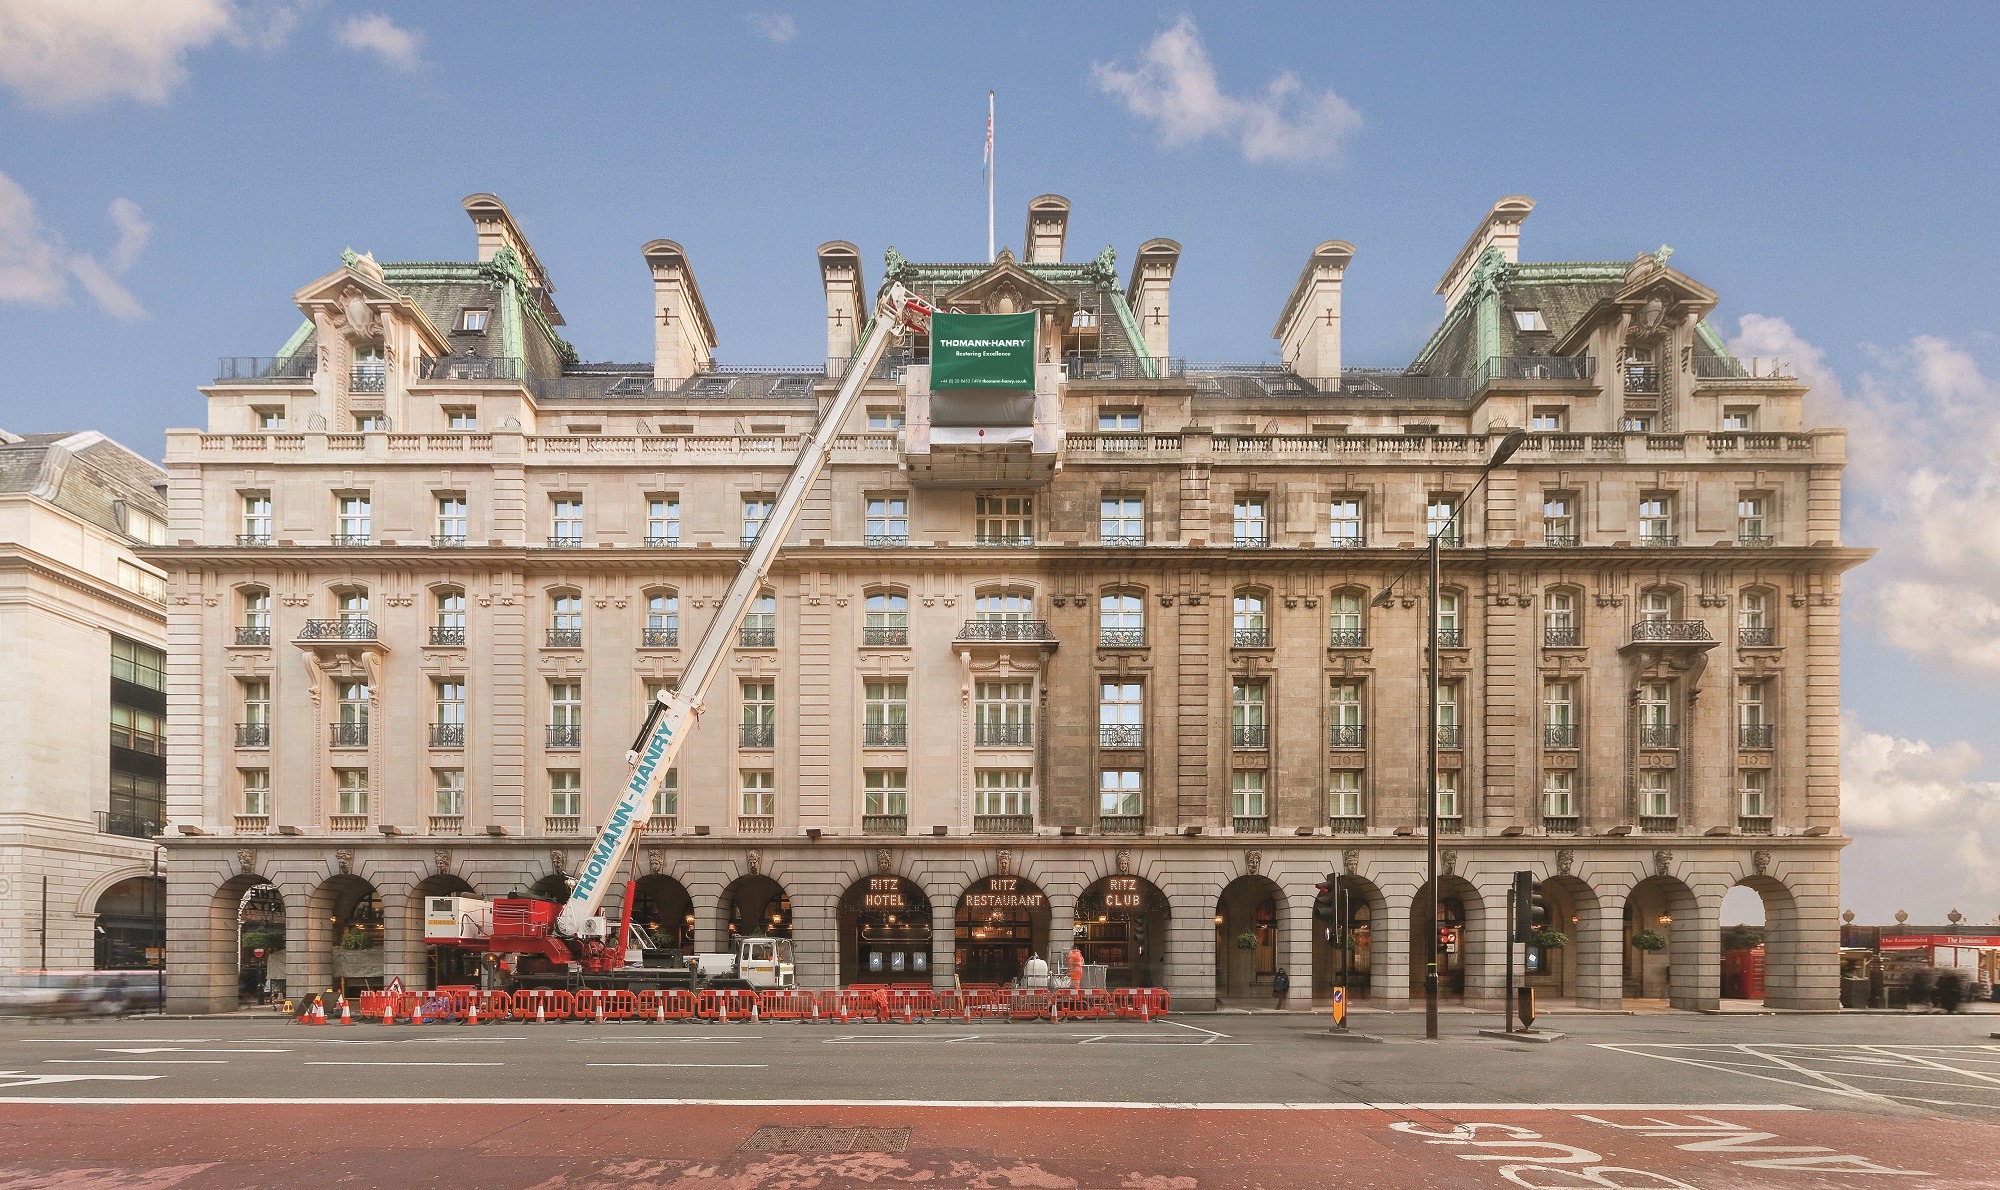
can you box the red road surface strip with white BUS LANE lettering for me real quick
[0,1102,2000,1190]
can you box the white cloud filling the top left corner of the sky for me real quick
[0,0,316,108]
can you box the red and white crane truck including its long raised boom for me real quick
[424,284,932,990]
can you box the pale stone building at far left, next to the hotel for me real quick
[0,430,166,976]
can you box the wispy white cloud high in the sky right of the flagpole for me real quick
[1092,16,1362,162]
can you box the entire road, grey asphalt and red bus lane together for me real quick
[0,1014,2000,1190]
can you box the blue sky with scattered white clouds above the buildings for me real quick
[0,0,2000,920]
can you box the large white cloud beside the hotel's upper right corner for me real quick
[1730,314,2000,678]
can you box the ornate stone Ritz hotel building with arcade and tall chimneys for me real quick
[146,194,1866,1010]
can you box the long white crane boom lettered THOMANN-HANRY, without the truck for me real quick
[556,284,932,936]
